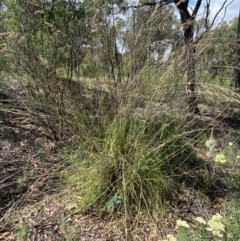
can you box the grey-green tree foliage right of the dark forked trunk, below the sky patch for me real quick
[197,18,238,87]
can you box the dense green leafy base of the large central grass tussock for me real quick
[65,112,195,212]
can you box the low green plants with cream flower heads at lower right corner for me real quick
[170,138,240,241]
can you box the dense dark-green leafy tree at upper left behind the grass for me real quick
[5,0,90,95]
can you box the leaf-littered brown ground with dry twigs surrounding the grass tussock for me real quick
[0,87,240,241]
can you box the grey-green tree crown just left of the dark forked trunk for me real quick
[124,1,177,75]
